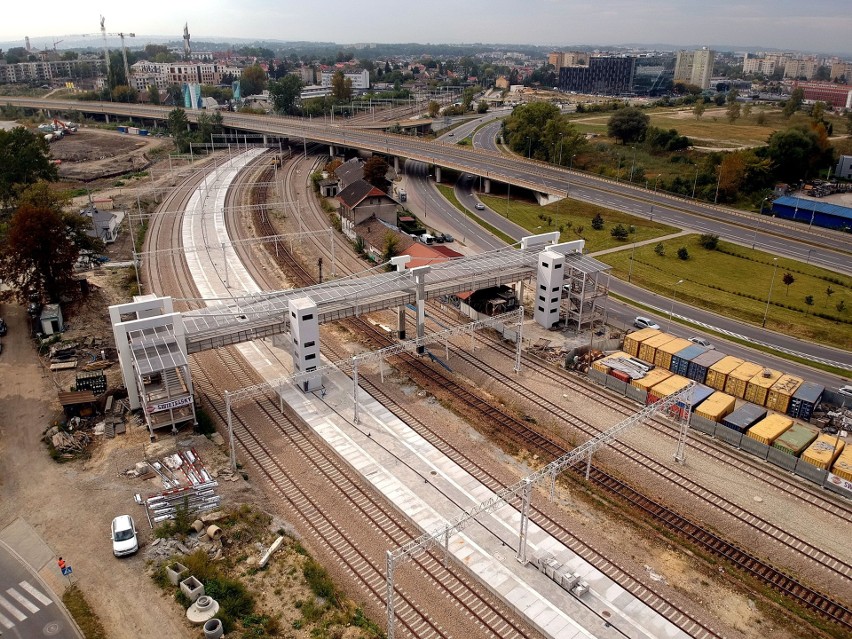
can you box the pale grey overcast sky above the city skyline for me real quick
[0,0,852,53]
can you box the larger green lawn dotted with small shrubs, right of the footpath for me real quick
[598,235,852,349]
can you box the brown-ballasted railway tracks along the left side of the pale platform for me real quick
[146,154,537,638]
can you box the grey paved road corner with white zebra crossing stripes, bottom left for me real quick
[0,542,81,639]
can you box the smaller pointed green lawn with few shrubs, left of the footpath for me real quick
[480,195,679,253]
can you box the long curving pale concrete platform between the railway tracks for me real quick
[183,151,689,639]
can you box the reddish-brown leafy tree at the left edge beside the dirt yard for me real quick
[0,182,103,302]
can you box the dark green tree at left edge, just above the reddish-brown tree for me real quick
[0,126,58,207]
